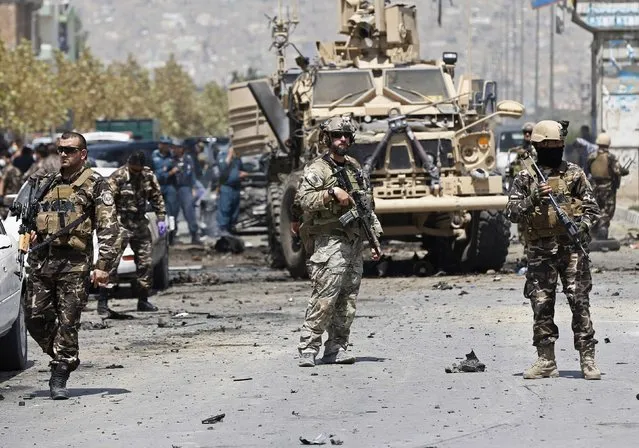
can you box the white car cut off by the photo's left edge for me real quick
[0,221,27,371]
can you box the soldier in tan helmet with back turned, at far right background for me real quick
[587,134,630,240]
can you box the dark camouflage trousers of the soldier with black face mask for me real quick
[524,246,597,350]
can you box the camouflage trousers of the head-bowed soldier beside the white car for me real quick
[110,220,152,298]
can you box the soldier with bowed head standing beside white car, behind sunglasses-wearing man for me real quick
[98,151,167,316]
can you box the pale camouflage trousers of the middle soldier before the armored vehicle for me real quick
[298,235,363,355]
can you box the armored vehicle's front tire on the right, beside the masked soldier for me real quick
[464,210,510,272]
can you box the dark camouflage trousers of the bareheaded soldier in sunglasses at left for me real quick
[25,272,89,370]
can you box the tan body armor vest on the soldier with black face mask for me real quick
[527,176,583,241]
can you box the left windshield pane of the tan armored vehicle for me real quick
[313,70,373,106]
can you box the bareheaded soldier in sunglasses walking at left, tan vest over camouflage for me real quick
[25,132,119,400]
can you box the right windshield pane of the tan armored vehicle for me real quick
[386,69,448,103]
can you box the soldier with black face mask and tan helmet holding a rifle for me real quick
[506,120,601,379]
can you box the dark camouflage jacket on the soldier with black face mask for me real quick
[506,161,600,249]
